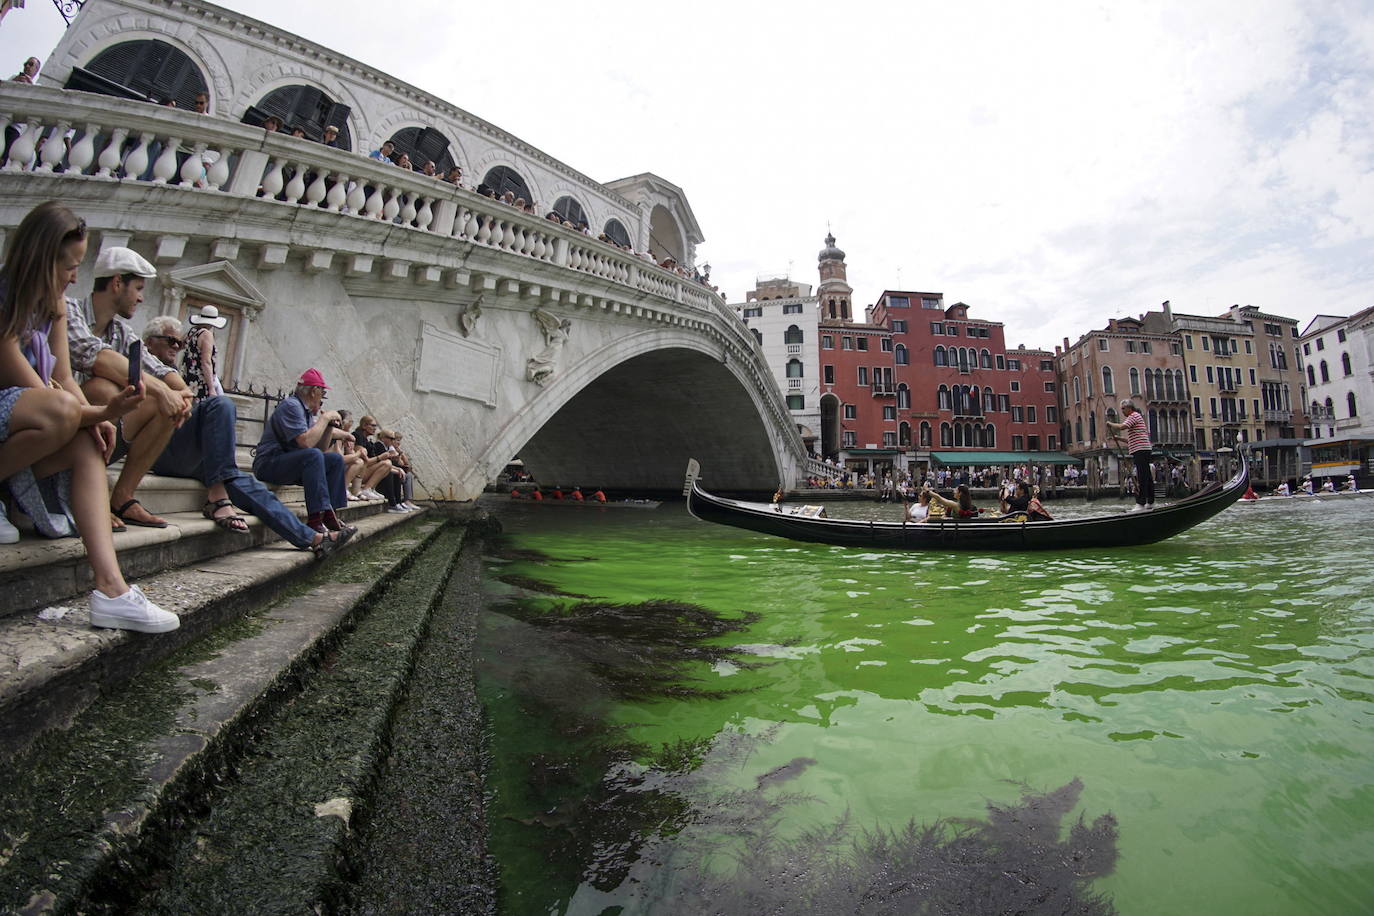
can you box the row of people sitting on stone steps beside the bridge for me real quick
[0,201,419,633]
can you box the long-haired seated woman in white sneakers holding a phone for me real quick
[0,201,180,633]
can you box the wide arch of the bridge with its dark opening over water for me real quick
[473,330,793,493]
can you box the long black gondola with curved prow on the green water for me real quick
[683,461,1249,551]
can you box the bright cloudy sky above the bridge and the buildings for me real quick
[0,0,1374,346]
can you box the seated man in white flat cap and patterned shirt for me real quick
[67,247,191,531]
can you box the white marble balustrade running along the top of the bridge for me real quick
[0,82,743,318]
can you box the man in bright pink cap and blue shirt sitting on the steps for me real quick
[253,369,352,531]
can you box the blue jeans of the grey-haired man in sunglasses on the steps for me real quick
[153,397,315,547]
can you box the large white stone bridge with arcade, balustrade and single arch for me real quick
[0,0,808,499]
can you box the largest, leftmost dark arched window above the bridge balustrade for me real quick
[66,38,208,112]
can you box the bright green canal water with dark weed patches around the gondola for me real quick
[478,497,1374,915]
